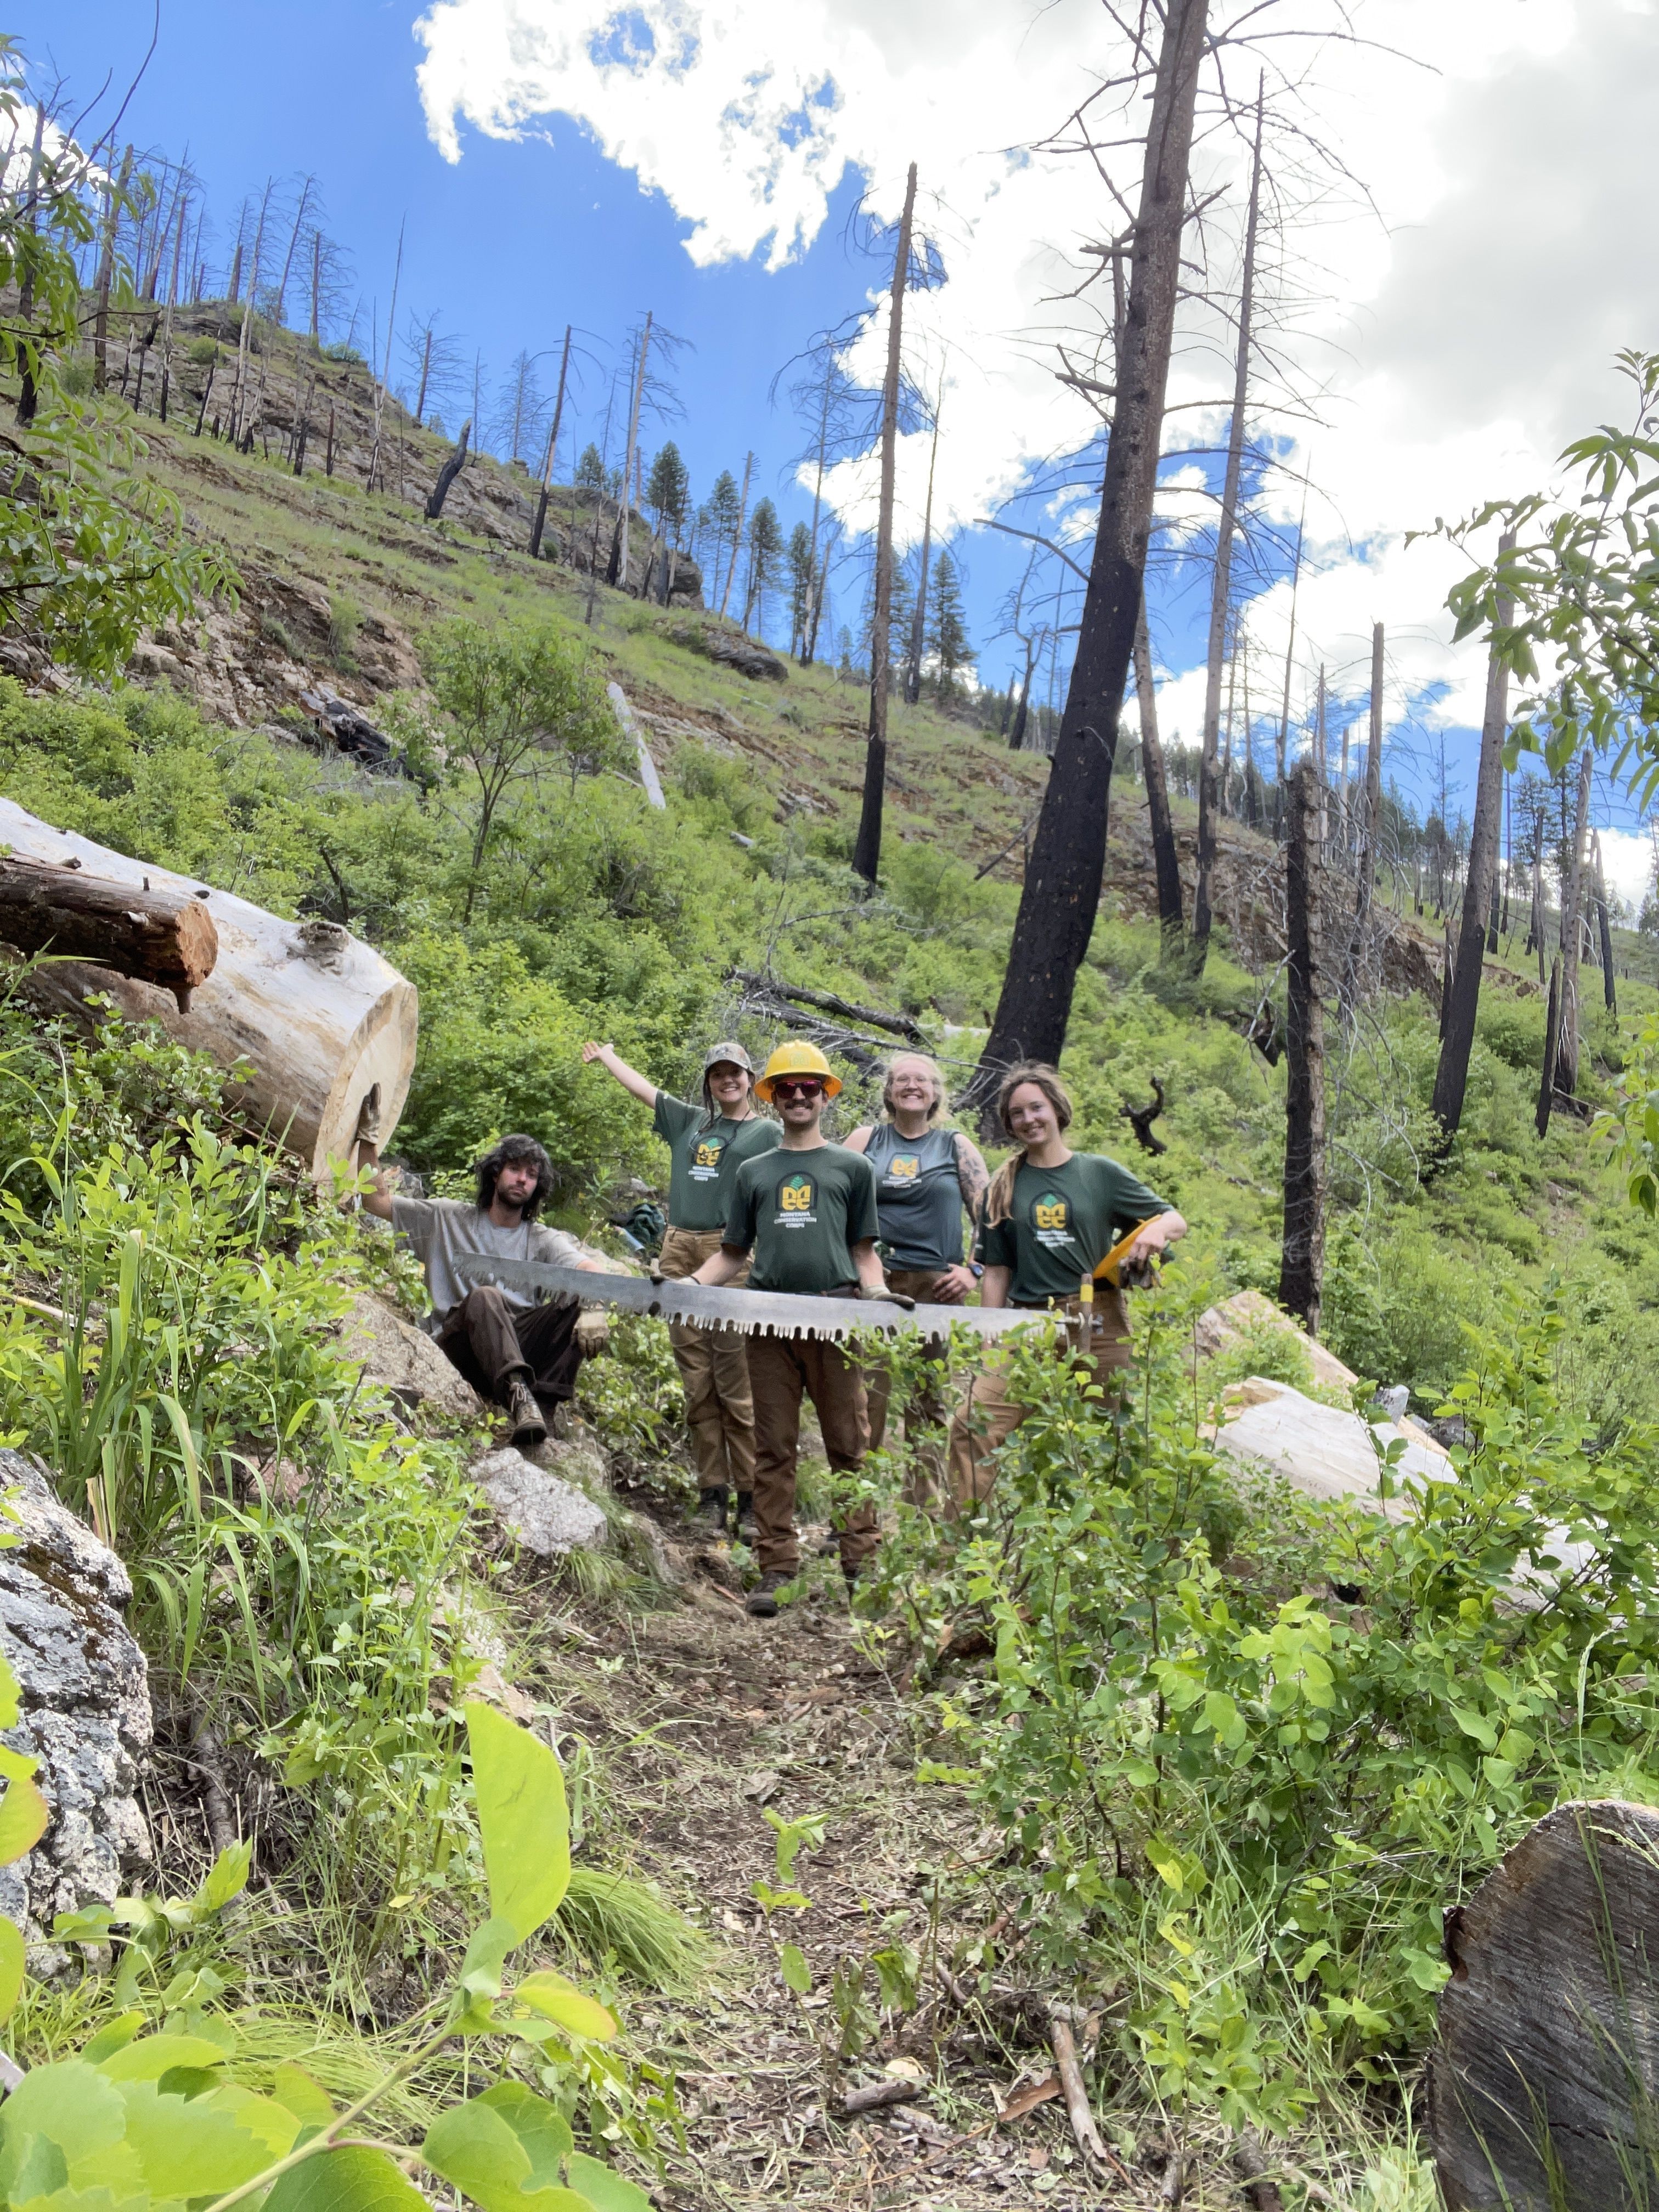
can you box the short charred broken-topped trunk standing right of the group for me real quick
[1278,754,1325,1336]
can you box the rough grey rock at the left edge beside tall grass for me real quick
[0,1451,153,1968]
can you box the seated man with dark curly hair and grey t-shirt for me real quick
[358,1137,608,1449]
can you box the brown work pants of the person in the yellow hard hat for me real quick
[750,1336,881,1575]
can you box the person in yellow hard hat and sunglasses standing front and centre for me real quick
[692,1044,887,1619]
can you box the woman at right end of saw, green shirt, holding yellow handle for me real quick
[951,1059,1186,1513]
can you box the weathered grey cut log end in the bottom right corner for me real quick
[1429,1801,1659,2212]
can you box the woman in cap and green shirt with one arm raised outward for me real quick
[582,1040,781,1533]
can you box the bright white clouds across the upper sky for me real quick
[416,0,1659,809]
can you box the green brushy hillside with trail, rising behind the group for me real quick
[0,321,1659,2212]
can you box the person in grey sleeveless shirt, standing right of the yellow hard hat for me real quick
[847,1053,991,1504]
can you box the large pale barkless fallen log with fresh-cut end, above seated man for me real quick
[0,799,418,1177]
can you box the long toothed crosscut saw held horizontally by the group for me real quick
[456,1252,1048,1342]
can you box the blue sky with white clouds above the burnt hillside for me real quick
[13,0,1659,883]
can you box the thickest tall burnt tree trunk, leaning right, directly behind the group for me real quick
[969,0,1207,1102]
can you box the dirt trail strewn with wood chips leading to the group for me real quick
[520,1531,1186,2212]
